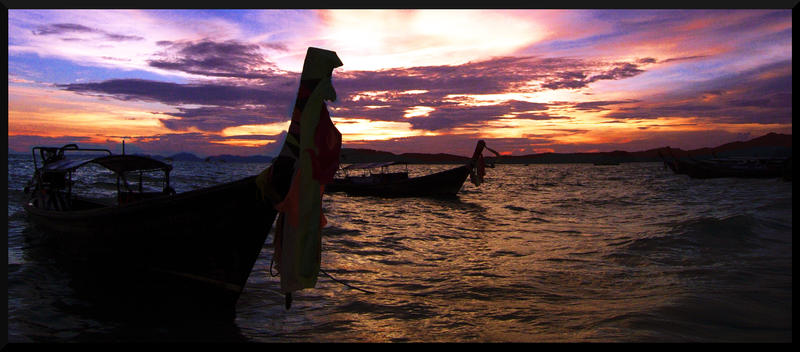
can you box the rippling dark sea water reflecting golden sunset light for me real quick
[7,155,792,342]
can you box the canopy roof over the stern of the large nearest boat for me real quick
[44,155,172,174]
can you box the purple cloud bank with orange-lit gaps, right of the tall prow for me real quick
[334,56,644,131]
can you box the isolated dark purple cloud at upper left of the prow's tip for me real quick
[148,39,282,79]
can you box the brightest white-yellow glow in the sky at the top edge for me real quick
[319,10,550,70]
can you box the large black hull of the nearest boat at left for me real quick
[25,177,276,314]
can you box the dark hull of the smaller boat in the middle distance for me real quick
[325,165,470,197]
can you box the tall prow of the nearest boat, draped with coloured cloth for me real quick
[256,47,342,309]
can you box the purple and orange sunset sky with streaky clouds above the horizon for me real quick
[8,9,792,156]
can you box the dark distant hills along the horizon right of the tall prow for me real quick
[340,133,792,164]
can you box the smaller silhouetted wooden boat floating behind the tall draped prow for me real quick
[325,141,494,197]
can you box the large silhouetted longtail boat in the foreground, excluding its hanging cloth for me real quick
[24,48,341,317]
